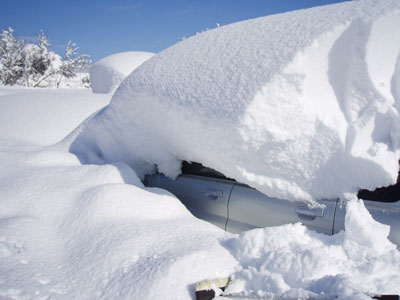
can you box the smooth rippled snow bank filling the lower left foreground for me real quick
[0,144,236,300]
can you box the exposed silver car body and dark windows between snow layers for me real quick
[145,162,400,245]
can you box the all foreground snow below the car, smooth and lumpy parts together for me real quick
[0,113,400,299]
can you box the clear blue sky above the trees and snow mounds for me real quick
[0,0,343,61]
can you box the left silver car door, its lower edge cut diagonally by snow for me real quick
[149,174,235,229]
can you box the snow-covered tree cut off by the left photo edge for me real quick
[0,27,24,85]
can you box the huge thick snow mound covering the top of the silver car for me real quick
[71,0,400,204]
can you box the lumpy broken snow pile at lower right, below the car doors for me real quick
[221,200,400,299]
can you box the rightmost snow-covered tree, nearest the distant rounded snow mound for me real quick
[57,41,92,87]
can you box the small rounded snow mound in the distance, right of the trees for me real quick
[89,51,155,94]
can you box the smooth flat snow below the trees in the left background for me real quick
[0,88,111,145]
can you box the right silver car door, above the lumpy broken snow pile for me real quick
[226,184,337,234]
